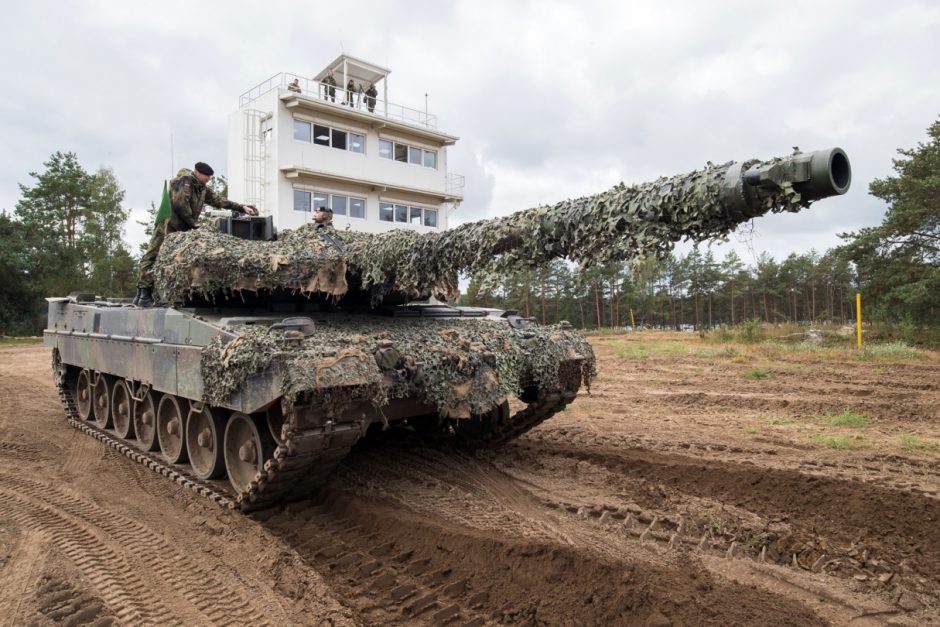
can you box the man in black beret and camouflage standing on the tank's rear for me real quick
[134,161,258,307]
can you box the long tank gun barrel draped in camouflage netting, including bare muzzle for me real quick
[348,148,852,300]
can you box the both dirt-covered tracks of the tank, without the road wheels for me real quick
[57,368,577,512]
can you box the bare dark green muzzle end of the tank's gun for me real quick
[721,148,852,218]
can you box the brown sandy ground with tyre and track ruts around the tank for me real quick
[0,334,940,626]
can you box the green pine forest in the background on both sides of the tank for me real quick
[0,116,940,335]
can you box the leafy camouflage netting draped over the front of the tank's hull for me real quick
[202,318,596,418]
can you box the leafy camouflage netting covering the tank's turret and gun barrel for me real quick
[157,159,816,304]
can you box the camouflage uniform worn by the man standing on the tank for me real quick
[137,168,245,288]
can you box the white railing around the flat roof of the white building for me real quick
[238,72,437,129]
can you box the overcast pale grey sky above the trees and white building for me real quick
[0,0,940,263]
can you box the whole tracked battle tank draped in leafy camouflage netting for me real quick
[45,148,851,511]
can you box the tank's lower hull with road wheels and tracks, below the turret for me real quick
[44,298,593,511]
